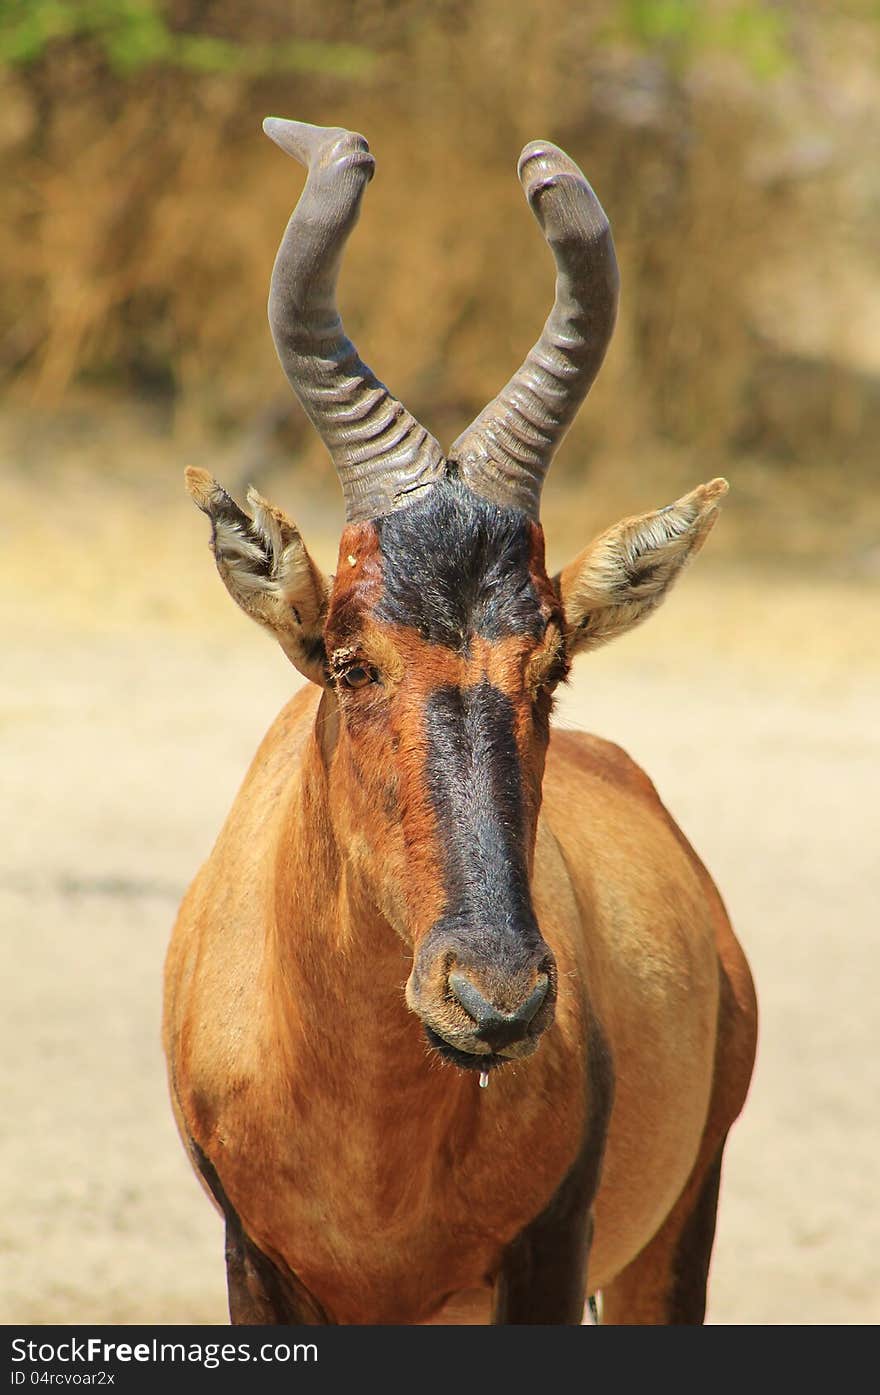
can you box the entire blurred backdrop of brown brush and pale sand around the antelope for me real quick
[0,0,880,1322]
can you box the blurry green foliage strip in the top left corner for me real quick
[0,0,374,77]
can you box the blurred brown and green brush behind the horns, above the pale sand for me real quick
[0,0,880,560]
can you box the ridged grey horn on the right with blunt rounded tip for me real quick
[449,141,619,520]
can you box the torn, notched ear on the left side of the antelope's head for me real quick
[185,466,329,684]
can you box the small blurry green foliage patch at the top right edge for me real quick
[614,0,789,78]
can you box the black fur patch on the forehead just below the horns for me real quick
[375,480,545,650]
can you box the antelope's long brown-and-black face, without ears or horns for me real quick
[324,491,568,1069]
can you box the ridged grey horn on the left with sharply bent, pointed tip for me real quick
[262,117,446,523]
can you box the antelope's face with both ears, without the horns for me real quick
[187,470,727,1070]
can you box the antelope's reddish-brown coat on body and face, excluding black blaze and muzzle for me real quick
[165,487,756,1322]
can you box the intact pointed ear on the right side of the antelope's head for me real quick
[556,480,728,654]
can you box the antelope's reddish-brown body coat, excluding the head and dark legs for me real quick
[166,675,753,1322]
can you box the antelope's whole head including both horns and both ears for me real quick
[188,119,727,1073]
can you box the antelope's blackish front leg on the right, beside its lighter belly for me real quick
[492,1024,614,1325]
